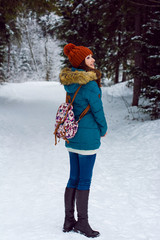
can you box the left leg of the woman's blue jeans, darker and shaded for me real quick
[67,152,79,188]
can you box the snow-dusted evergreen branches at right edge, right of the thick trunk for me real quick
[142,9,160,119]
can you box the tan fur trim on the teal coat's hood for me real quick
[59,68,97,85]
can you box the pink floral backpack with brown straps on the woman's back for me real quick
[54,85,90,145]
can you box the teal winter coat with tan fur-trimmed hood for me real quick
[60,68,107,150]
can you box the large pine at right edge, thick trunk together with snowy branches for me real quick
[129,0,160,119]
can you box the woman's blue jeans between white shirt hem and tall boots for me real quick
[67,152,96,190]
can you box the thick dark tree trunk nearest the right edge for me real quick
[132,8,142,106]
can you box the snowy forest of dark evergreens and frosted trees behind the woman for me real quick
[0,0,160,119]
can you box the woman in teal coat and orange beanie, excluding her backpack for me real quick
[60,43,107,237]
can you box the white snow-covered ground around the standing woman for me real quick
[0,82,160,240]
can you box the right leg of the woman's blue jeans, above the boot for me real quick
[77,154,96,190]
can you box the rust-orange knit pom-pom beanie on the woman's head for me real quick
[64,43,93,68]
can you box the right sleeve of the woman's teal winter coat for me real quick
[86,81,107,136]
